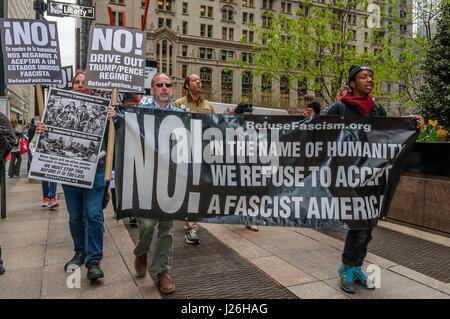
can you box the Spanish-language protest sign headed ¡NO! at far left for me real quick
[0,19,63,85]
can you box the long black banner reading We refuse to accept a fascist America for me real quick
[115,107,418,229]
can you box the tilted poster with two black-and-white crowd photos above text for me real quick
[29,88,109,188]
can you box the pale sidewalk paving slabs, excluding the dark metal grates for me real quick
[0,178,450,299]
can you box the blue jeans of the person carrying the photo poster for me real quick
[63,170,106,266]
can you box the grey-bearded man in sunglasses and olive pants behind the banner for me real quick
[108,73,179,294]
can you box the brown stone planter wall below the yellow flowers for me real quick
[387,143,450,234]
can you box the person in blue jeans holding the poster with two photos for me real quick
[36,70,108,280]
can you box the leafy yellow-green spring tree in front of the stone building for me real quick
[235,0,427,107]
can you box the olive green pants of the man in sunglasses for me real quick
[134,218,173,274]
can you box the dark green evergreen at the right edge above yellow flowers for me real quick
[417,1,450,128]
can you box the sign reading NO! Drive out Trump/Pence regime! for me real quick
[86,26,146,93]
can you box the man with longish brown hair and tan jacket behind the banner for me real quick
[173,74,216,245]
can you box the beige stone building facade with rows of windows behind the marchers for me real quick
[90,0,412,113]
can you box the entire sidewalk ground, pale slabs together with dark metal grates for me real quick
[0,158,450,299]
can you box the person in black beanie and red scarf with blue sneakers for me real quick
[328,65,424,293]
